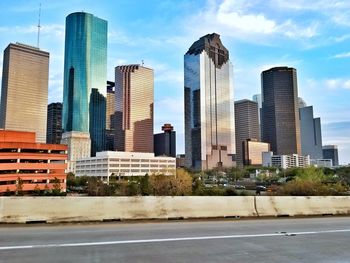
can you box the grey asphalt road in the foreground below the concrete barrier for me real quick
[0,217,350,263]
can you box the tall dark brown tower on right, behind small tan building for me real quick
[261,67,301,155]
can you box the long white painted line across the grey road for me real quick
[0,229,350,251]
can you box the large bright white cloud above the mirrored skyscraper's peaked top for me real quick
[186,0,319,44]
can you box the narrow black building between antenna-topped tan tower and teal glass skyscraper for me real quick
[46,102,62,144]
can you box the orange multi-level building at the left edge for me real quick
[0,130,67,194]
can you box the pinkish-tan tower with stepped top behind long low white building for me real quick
[115,65,154,153]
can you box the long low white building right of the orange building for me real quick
[75,151,176,181]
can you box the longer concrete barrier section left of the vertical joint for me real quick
[0,196,256,223]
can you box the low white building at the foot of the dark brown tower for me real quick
[262,152,310,169]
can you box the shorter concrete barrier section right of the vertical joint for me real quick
[256,196,350,216]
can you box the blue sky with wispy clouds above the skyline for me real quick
[0,0,350,164]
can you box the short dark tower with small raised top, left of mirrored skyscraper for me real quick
[154,123,176,157]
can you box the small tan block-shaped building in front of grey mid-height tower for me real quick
[242,139,270,166]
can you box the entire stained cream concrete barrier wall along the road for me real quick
[0,196,350,223]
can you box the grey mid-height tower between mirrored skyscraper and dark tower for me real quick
[235,100,259,167]
